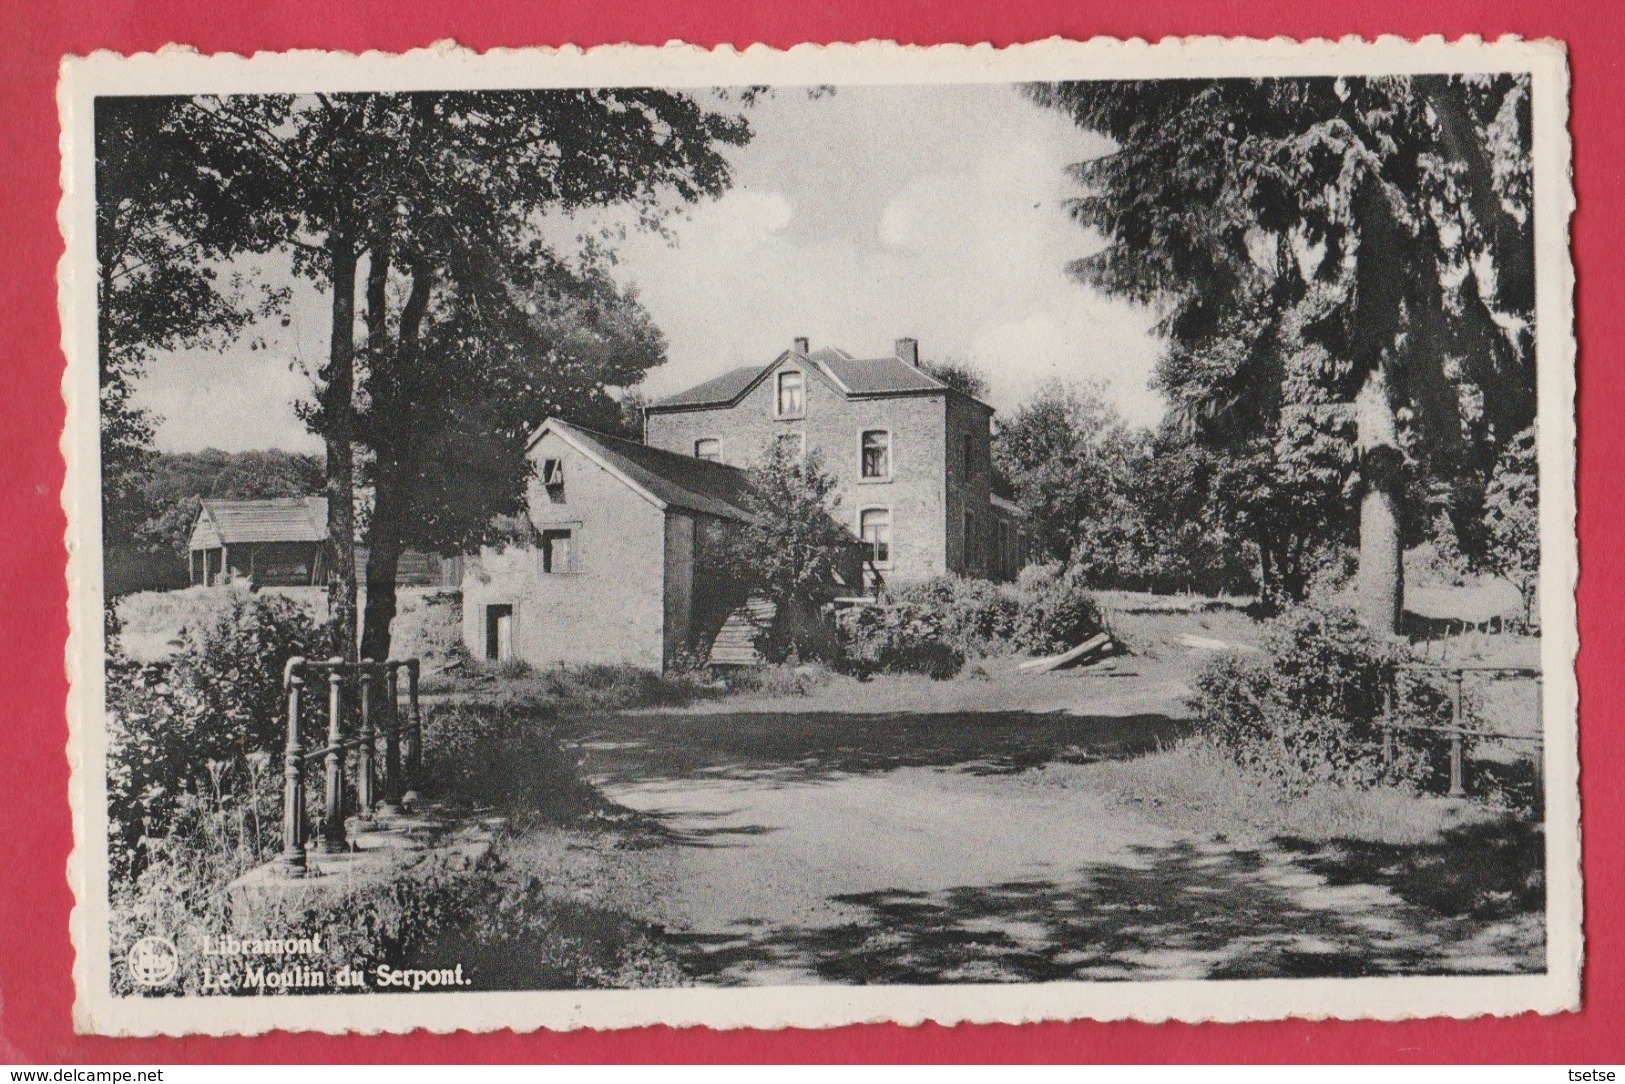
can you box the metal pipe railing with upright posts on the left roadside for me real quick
[278,657,423,876]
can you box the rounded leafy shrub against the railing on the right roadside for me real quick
[1191,605,1441,795]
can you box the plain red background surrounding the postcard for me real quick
[0,0,1625,1063]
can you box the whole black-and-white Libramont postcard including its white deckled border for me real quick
[60,39,1583,1035]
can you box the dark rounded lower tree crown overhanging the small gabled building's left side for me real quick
[356,263,665,658]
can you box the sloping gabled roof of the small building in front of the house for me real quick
[531,418,751,520]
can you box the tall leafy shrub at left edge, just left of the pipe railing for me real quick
[107,595,327,879]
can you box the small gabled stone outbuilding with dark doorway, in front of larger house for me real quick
[463,419,763,670]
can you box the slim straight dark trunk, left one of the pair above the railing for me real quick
[322,236,358,660]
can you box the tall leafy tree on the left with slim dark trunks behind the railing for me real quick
[117,88,749,653]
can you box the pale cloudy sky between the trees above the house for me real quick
[140,86,1162,450]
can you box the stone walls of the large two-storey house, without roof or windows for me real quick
[644,340,1016,583]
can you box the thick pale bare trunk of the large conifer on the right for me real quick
[1354,364,1404,634]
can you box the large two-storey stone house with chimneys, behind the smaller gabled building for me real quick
[644,338,1027,583]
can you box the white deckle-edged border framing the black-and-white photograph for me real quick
[59,37,1583,1035]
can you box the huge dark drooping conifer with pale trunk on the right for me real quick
[1029,75,1534,631]
